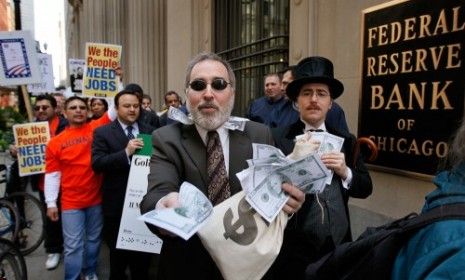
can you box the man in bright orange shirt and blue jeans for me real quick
[45,96,116,280]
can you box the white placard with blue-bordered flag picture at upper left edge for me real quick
[0,31,41,86]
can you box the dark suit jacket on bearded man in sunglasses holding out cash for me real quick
[141,122,272,279]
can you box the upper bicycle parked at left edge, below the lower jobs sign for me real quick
[0,164,46,256]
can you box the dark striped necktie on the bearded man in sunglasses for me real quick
[207,131,231,205]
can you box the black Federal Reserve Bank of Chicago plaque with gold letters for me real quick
[359,0,465,178]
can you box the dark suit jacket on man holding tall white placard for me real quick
[92,120,152,218]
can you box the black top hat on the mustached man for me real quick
[286,56,344,101]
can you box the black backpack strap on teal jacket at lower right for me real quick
[401,203,465,233]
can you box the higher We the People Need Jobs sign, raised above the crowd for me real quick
[82,43,121,98]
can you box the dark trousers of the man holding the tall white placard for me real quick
[103,216,152,280]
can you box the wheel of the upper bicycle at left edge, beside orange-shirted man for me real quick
[8,192,45,255]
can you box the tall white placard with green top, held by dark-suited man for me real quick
[116,134,163,254]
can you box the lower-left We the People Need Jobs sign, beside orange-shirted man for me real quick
[13,122,50,177]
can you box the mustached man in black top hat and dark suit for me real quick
[267,56,372,279]
